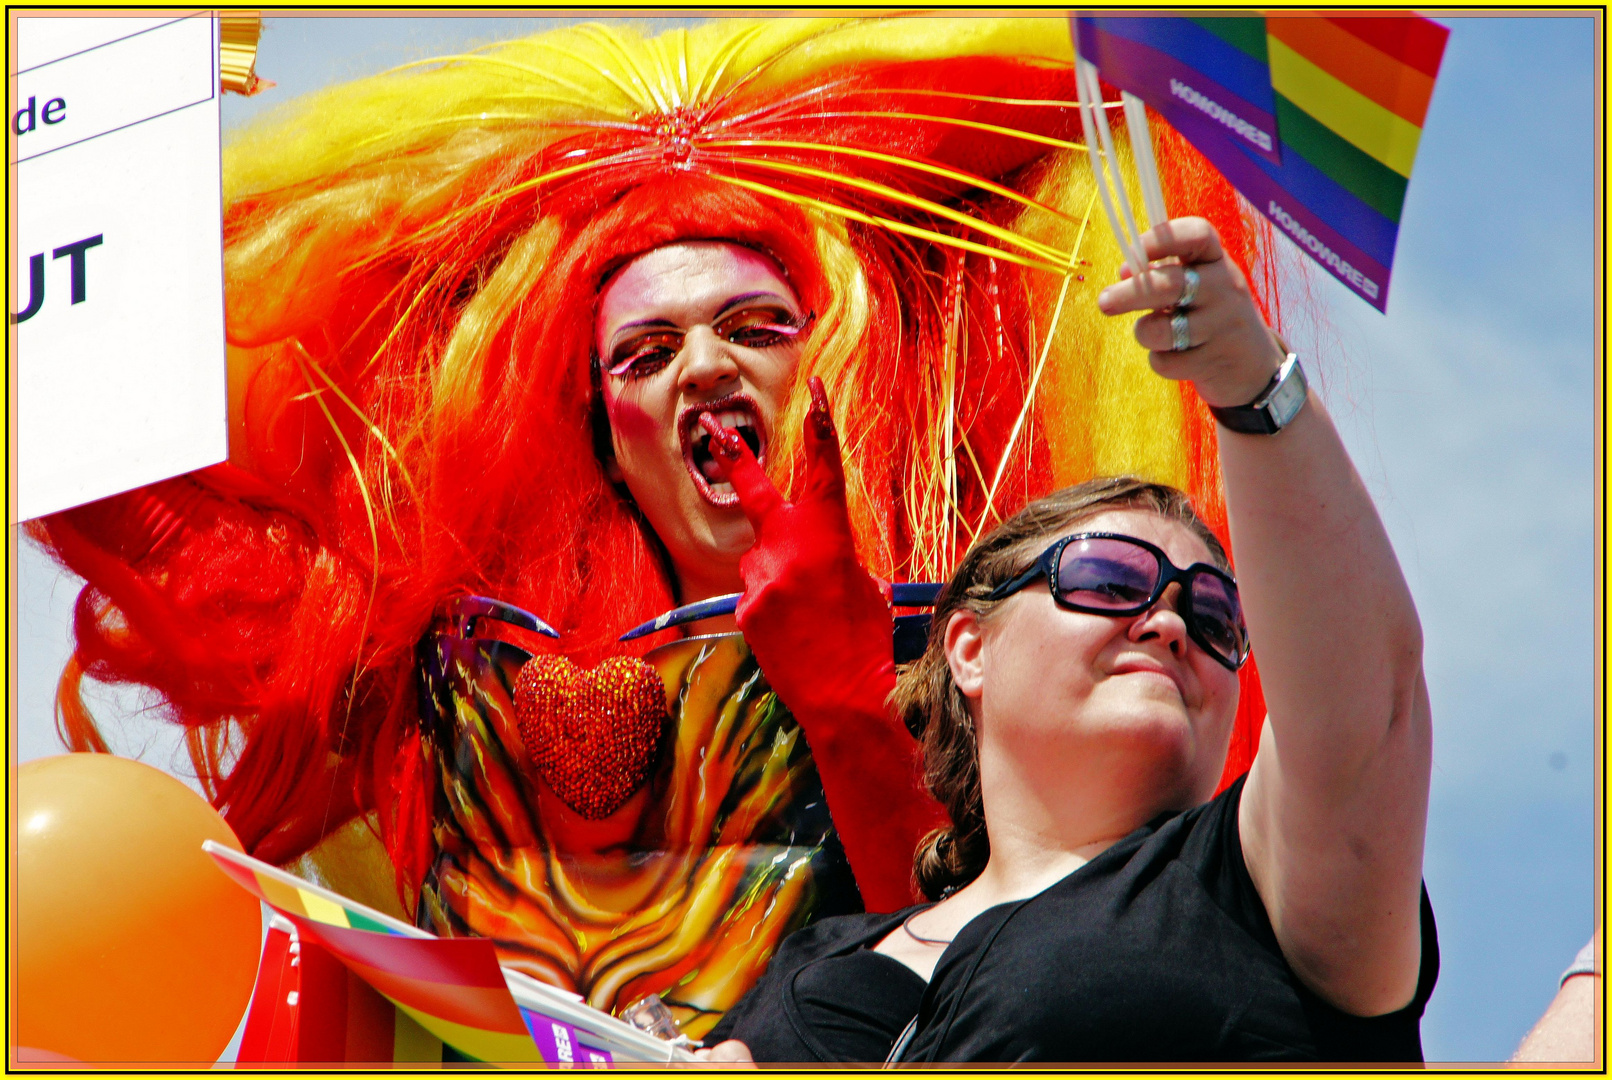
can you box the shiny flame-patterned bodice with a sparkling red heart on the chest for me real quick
[418,600,861,1038]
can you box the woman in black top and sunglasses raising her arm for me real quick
[699,219,1438,1062]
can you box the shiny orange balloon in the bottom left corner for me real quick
[11,754,261,1064]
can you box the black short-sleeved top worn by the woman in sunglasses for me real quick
[706,780,1438,1062]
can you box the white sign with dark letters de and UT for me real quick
[10,15,229,521]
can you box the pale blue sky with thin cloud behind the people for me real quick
[18,16,1599,1061]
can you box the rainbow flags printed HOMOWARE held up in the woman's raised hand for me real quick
[1074,13,1449,311]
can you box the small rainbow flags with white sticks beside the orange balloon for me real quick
[203,841,660,1067]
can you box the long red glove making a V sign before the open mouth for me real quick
[700,376,946,911]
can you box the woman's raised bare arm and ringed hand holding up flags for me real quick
[1099,218,1431,1016]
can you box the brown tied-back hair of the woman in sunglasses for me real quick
[890,476,1230,899]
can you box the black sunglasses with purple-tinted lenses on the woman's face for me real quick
[987,532,1248,671]
